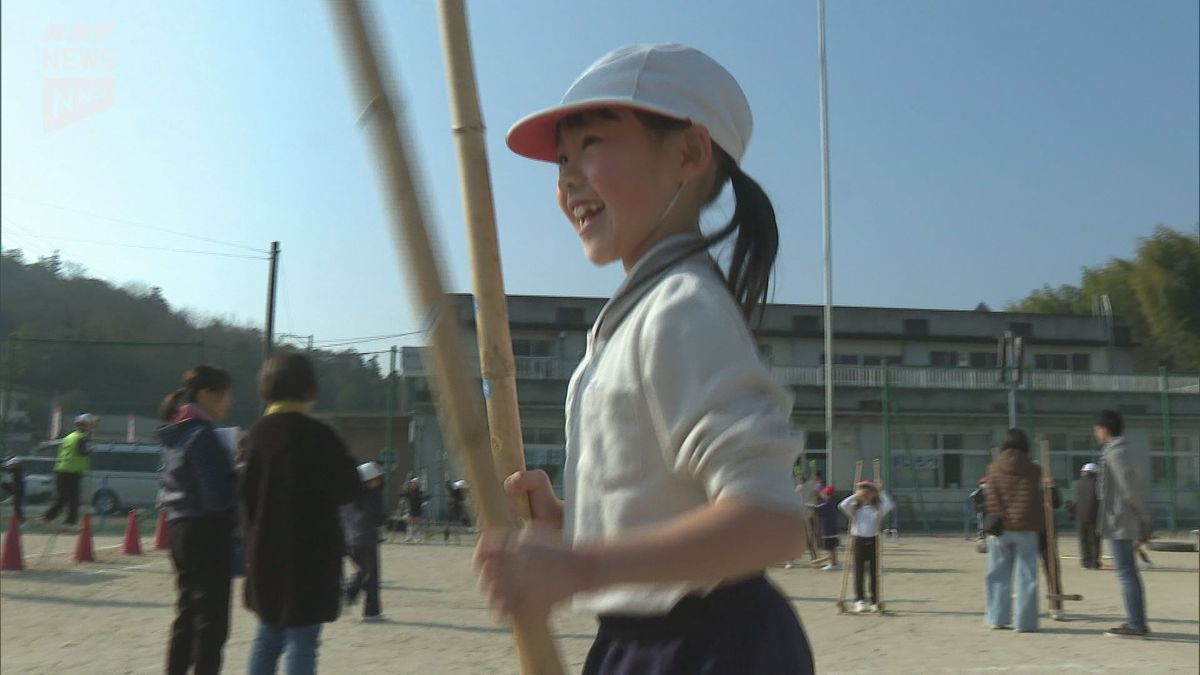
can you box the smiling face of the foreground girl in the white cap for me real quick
[558,108,698,271]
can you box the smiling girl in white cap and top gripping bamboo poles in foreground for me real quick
[476,44,812,675]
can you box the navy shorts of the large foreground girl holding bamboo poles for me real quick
[583,577,815,675]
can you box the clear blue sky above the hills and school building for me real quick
[0,0,1200,351]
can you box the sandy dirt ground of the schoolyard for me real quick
[0,526,1200,675]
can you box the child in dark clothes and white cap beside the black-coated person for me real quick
[341,461,384,621]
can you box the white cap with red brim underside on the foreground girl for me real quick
[508,44,754,162]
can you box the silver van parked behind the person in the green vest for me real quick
[31,441,162,514]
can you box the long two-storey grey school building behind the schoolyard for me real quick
[398,294,1200,530]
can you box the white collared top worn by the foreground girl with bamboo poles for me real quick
[564,235,804,615]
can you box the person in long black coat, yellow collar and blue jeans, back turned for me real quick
[241,353,359,675]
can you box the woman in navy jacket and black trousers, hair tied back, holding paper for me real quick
[158,365,238,675]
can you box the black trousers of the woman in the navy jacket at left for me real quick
[167,518,233,675]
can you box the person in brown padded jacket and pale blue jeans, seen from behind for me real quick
[985,429,1045,632]
